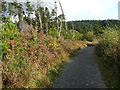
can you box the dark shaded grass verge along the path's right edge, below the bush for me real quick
[94,48,120,88]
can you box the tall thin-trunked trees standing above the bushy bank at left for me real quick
[0,0,66,36]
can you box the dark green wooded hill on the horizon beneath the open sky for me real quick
[67,20,120,34]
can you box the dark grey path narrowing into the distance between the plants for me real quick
[53,46,106,88]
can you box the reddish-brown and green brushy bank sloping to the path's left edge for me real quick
[1,25,86,88]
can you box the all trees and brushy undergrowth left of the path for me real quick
[0,1,86,88]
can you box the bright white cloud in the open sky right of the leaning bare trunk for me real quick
[61,0,119,19]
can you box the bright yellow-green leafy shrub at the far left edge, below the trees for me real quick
[0,22,19,58]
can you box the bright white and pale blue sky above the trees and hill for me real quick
[8,0,120,21]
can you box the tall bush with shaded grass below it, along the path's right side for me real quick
[95,28,120,88]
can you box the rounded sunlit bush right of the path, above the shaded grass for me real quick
[96,28,120,63]
